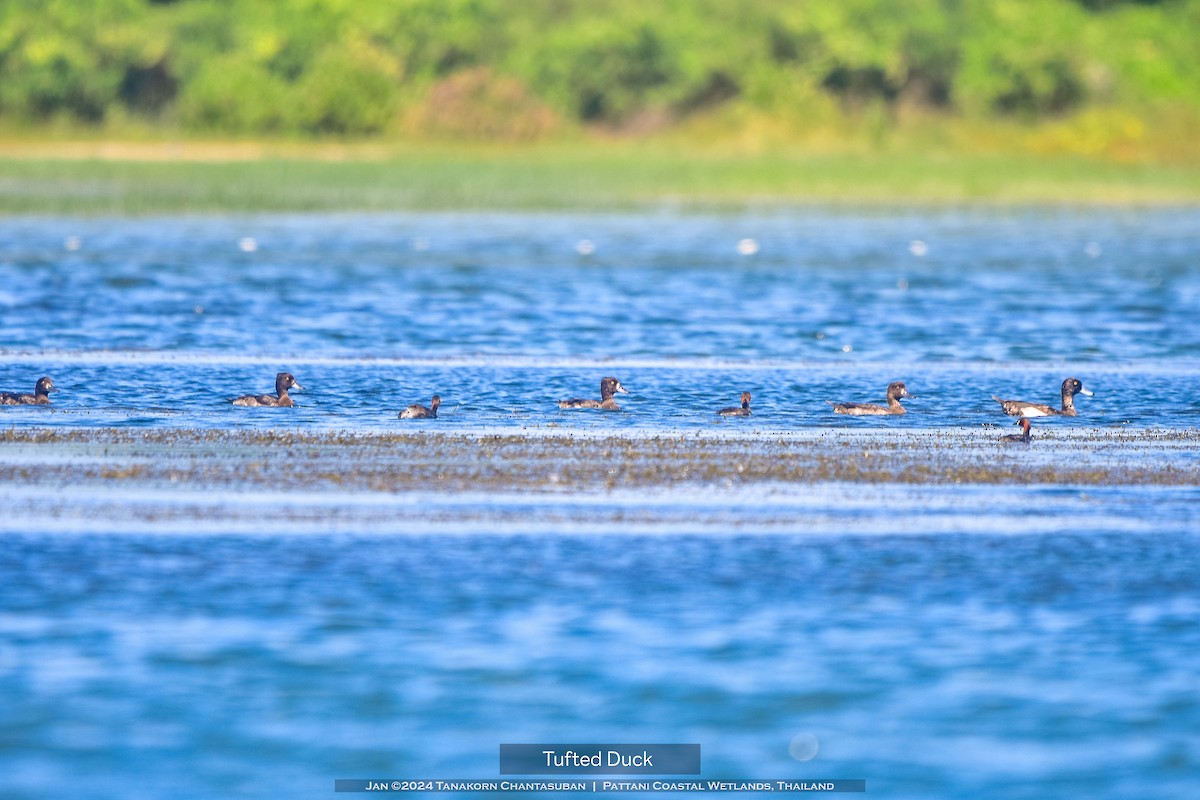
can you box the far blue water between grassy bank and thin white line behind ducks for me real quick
[0,209,1200,365]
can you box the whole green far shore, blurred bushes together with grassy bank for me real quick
[0,0,1200,215]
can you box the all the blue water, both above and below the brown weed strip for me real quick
[0,207,1200,800]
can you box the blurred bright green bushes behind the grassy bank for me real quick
[0,0,1200,140]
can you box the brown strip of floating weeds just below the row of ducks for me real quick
[0,428,1200,493]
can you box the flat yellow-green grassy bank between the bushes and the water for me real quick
[0,143,1200,215]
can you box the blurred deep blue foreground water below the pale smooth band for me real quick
[0,531,1200,800]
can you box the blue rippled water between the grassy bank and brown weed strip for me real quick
[0,209,1200,431]
